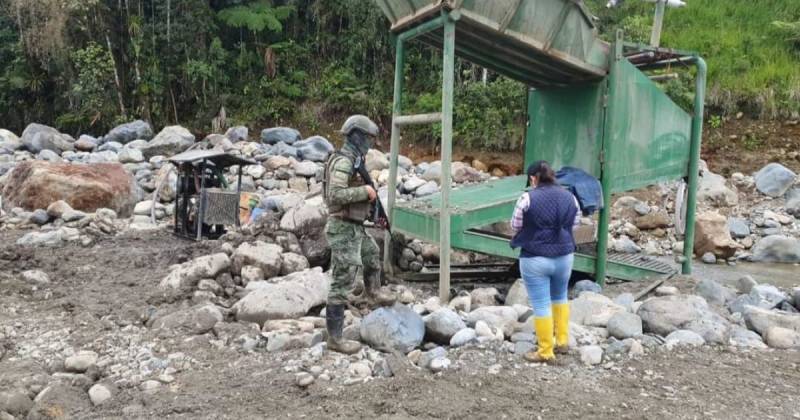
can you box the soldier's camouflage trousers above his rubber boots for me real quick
[325,218,381,305]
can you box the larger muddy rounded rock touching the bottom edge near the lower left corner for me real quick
[27,382,91,420]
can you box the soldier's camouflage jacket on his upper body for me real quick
[323,144,370,222]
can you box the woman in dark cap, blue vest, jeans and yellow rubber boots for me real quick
[511,160,580,362]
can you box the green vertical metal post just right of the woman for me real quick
[594,31,624,286]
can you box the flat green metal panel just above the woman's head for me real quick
[525,83,605,178]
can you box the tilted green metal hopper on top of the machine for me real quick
[377,0,610,87]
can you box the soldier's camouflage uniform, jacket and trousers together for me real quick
[324,143,381,304]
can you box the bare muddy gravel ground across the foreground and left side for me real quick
[0,232,800,419]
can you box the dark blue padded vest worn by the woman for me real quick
[511,185,578,258]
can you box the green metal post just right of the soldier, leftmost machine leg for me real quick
[383,35,406,275]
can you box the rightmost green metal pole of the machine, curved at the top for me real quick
[682,57,708,274]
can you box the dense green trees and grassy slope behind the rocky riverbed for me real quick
[0,0,800,150]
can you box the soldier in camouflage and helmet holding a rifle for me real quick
[323,115,395,354]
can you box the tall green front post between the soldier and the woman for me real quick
[439,16,456,303]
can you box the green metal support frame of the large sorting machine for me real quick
[384,5,707,302]
